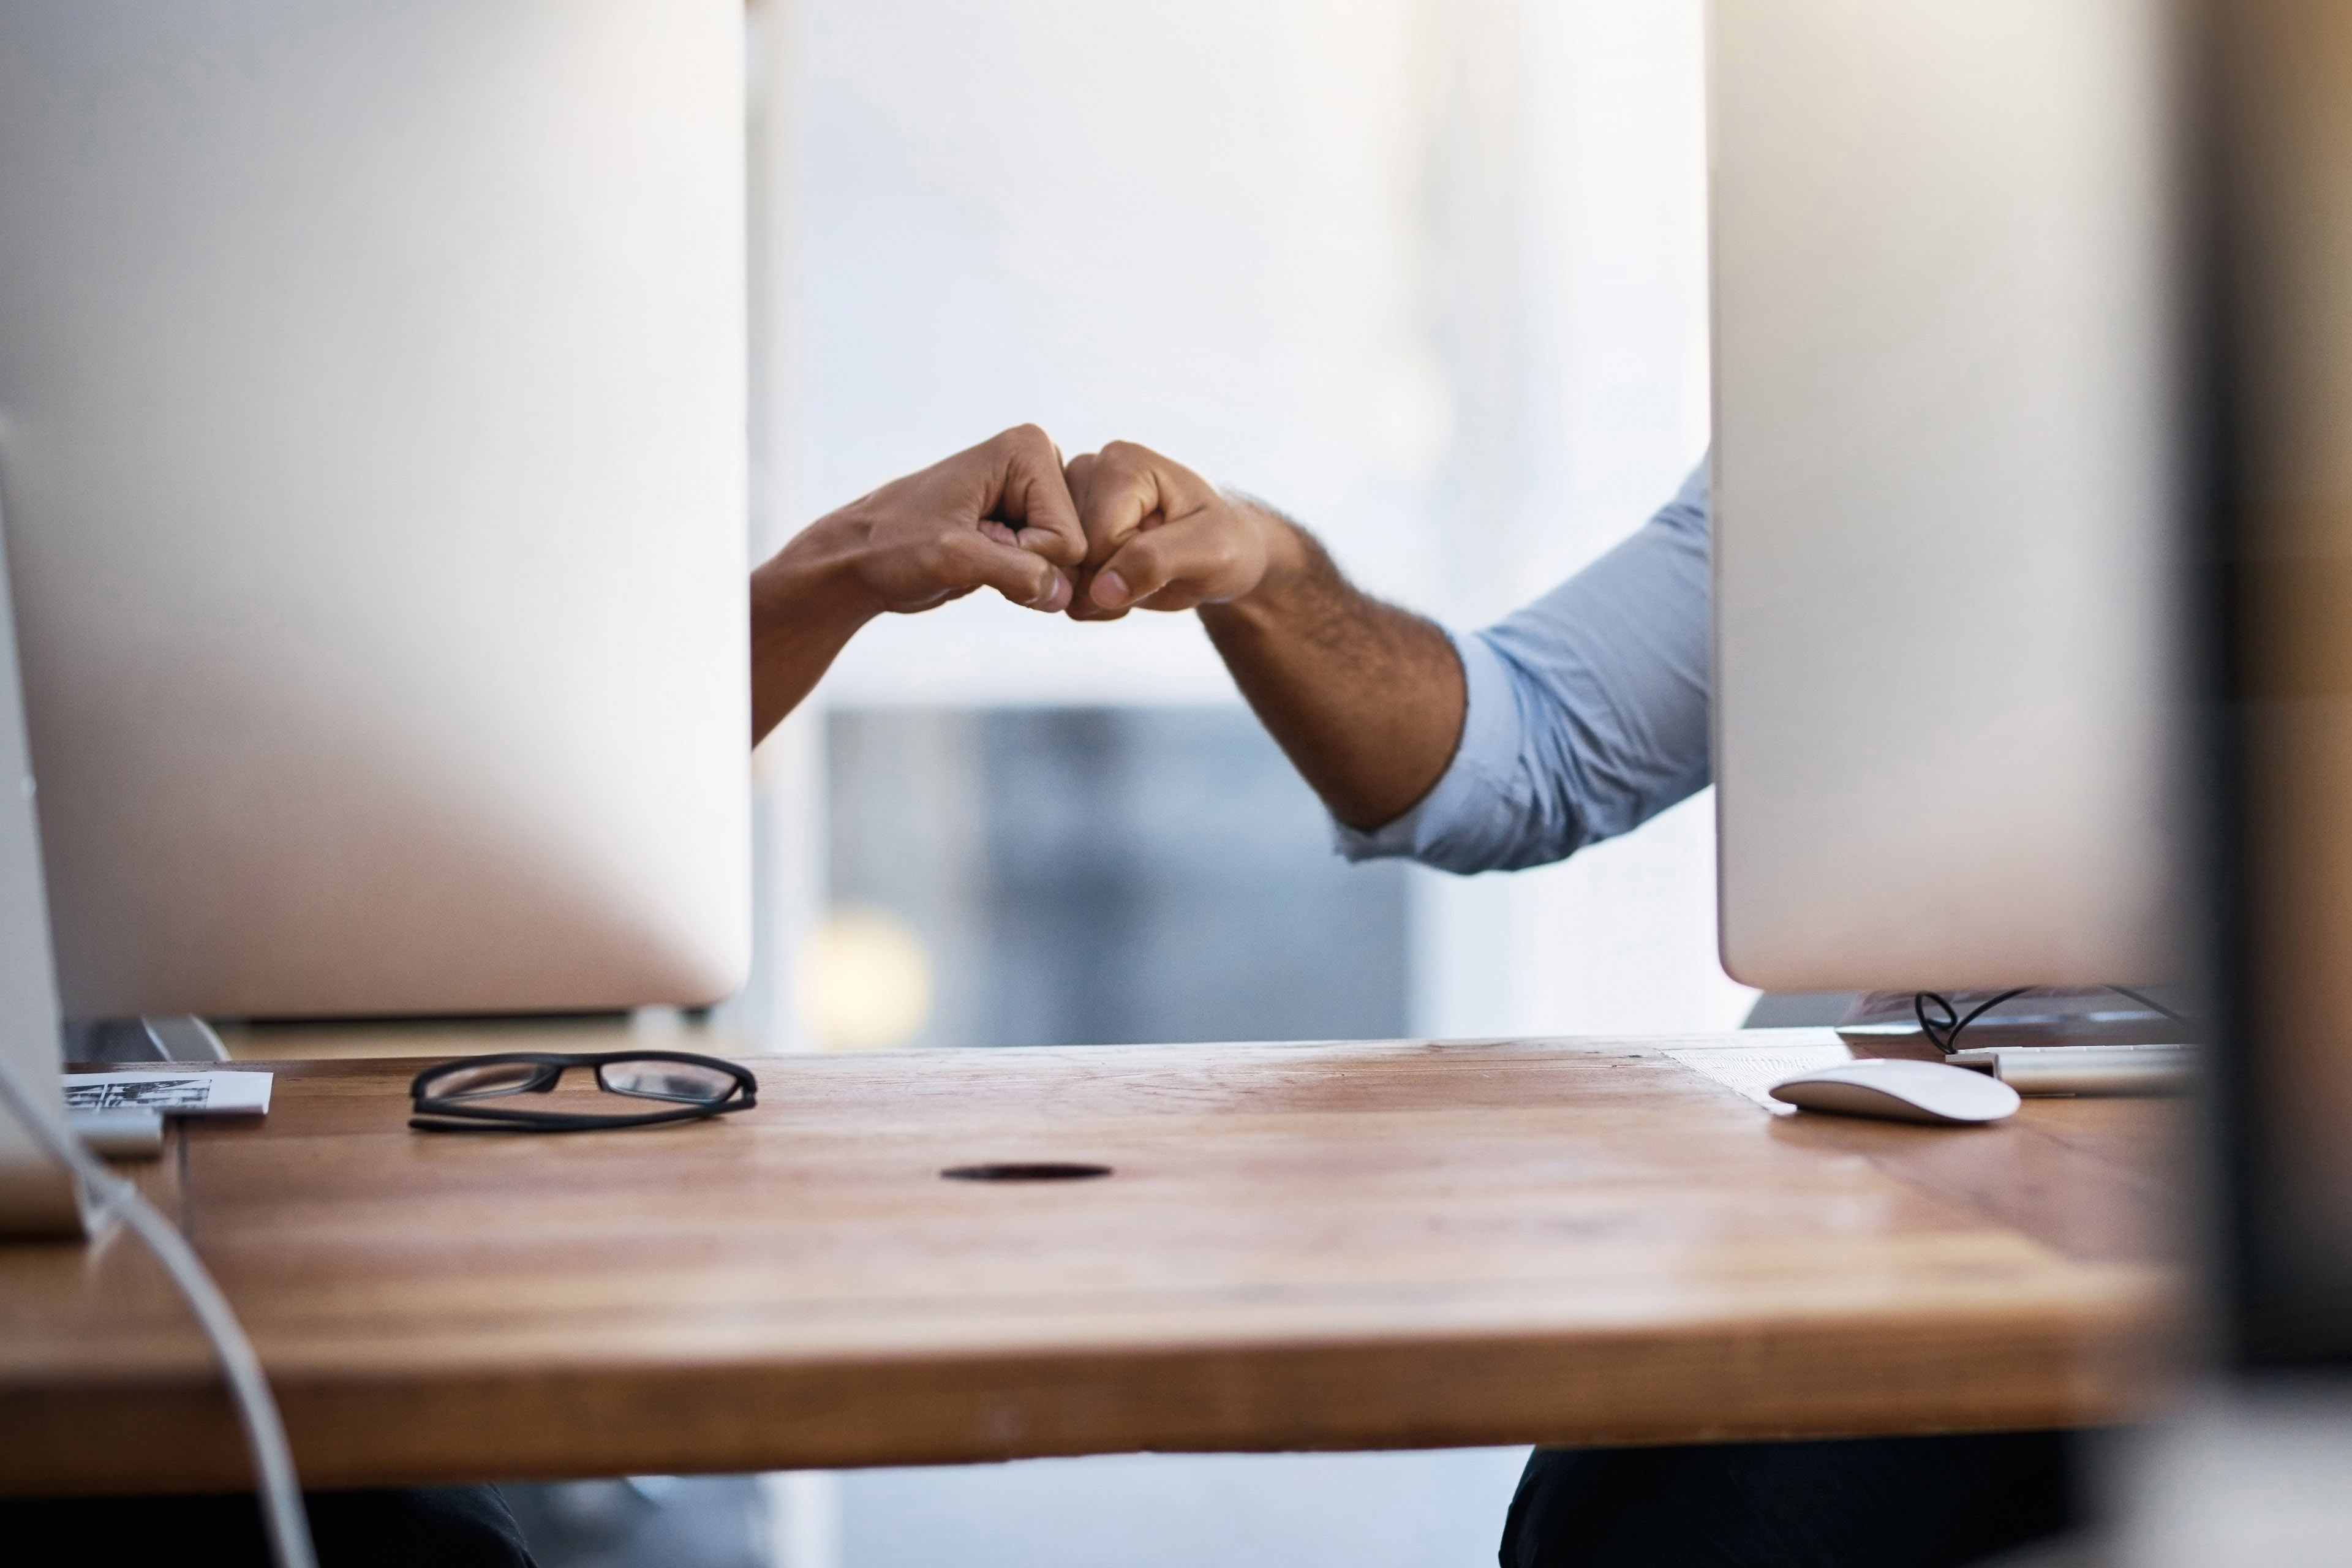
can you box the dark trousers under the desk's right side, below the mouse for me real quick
[1501,1431,2081,1568]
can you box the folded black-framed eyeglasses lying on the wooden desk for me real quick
[409,1051,760,1133]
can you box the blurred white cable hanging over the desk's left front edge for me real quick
[0,1055,317,1568]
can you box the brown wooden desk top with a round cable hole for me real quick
[0,1035,2173,1493]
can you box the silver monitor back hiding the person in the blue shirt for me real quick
[1710,0,2187,992]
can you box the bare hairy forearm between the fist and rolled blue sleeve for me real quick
[1199,508,1468,827]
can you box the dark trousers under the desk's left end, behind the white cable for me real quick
[0,1486,532,1568]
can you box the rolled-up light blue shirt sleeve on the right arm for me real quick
[1333,461,1710,872]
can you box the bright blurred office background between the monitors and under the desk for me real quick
[538,0,1752,1568]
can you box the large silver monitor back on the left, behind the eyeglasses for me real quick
[0,0,750,1025]
